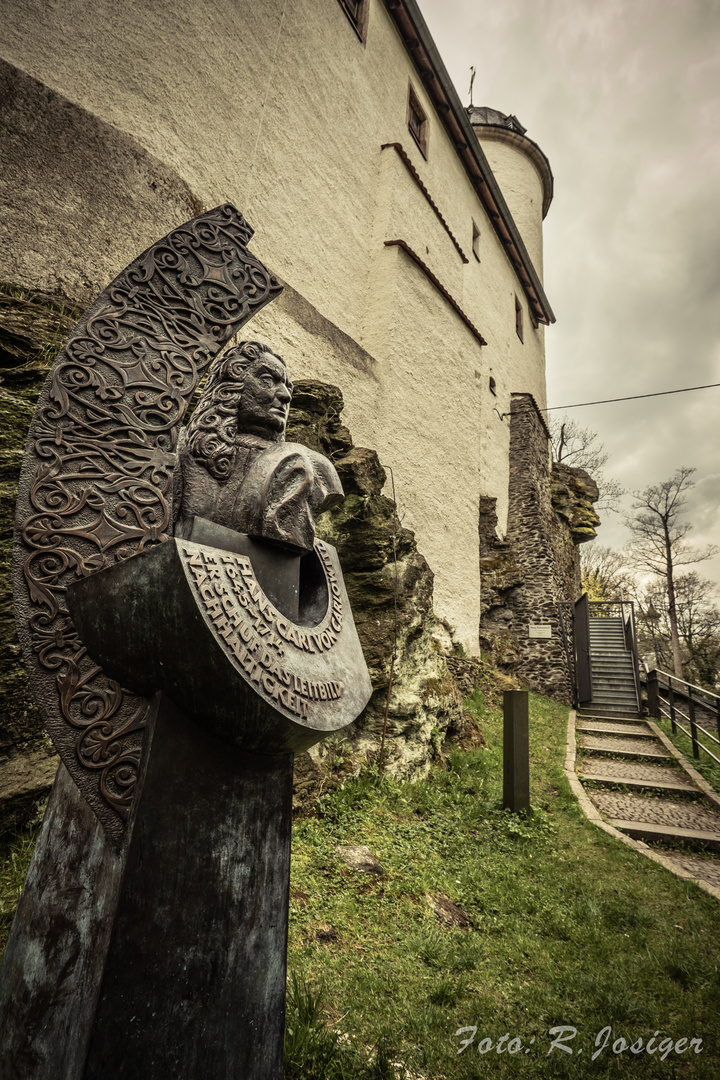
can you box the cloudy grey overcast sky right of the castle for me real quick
[419,0,720,581]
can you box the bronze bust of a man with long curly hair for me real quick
[174,341,342,552]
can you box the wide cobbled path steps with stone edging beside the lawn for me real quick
[575,713,720,896]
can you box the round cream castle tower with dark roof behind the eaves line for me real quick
[467,105,553,281]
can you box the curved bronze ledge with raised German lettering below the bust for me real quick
[68,523,372,754]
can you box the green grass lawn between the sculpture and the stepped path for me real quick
[0,678,720,1080]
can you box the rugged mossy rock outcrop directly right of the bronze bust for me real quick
[287,380,463,789]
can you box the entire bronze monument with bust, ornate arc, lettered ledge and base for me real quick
[0,206,371,1080]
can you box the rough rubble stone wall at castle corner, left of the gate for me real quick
[479,394,599,701]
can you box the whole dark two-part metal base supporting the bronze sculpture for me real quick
[0,696,293,1080]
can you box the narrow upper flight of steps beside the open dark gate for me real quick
[583,618,641,717]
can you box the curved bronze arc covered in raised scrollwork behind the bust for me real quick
[15,205,281,839]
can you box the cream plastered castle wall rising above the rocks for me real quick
[0,0,546,653]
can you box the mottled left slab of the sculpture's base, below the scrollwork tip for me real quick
[0,765,136,1080]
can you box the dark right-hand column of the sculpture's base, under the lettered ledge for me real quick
[82,699,293,1080]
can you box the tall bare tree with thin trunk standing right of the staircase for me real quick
[625,468,718,678]
